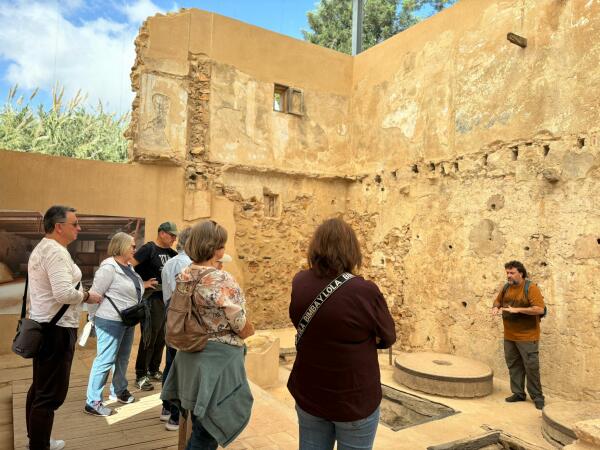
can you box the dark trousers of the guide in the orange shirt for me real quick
[504,339,544,400]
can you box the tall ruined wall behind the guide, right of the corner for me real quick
[349,0,600,399]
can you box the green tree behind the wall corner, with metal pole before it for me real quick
[302,0,456,54]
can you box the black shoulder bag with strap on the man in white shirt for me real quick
[12,275,81,358]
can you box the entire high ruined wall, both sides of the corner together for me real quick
[128,0,600,399]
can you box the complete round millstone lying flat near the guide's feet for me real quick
[394,352,494,398]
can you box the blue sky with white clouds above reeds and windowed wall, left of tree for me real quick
[0,0,317,113]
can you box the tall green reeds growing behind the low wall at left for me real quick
[0,86,129,162]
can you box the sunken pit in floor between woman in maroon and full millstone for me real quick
[379,384,459,431]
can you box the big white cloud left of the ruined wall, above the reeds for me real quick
[0,0,166,112]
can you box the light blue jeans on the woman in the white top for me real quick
[86,317,135,405]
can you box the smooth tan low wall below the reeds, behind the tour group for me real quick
[0,150,189,353]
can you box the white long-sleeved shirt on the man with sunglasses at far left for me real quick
[27,238,83,328]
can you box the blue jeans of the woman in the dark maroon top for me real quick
[296,405,379,450]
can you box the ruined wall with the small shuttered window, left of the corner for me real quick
[128,10,355,327]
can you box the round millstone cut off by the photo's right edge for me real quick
[542,401,600,448]
